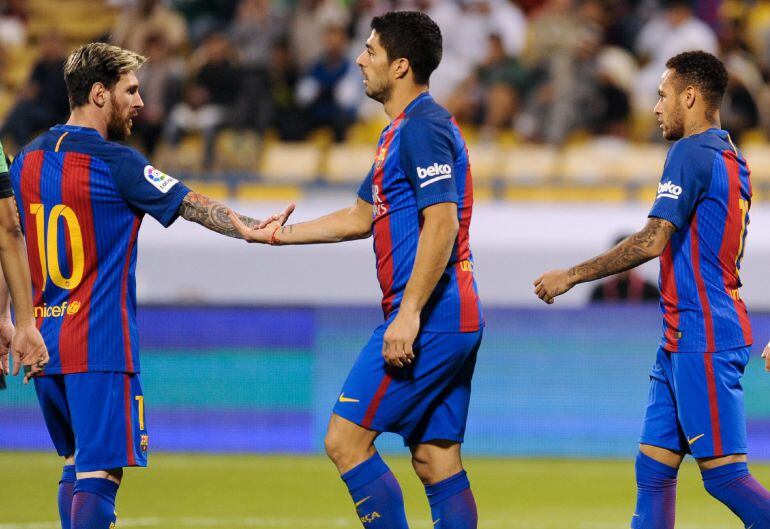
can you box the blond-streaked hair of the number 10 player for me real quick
[64,42,147,108]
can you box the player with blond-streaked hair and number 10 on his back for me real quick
[11,43,284,529]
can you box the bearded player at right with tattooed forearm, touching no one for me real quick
[535,51,770,529]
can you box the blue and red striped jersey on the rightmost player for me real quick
[650,129,752,353]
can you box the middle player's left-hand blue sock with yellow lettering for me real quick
[338,453,409,529]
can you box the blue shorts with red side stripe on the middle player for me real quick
[333,323,482,446]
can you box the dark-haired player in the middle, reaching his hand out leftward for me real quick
[231,11,483,529]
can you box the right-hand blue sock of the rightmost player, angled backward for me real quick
[701,463,770,529]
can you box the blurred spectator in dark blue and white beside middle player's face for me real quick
[297,25,363,141]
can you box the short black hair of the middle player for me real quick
[371,11,442,85]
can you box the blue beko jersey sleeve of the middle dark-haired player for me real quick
[399,119,459,209]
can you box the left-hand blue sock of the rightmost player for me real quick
[631,452,679,529]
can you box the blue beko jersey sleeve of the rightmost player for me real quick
[648,141,713,230]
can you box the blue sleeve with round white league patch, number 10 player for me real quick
[113,149,190,227]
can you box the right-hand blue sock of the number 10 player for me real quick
[71,478,118,529]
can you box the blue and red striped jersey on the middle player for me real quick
[358,92,484,332]
